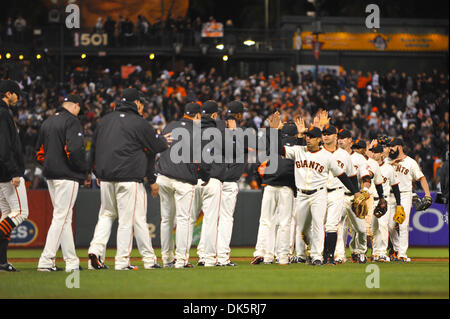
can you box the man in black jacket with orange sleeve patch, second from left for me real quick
[36,95,88,271]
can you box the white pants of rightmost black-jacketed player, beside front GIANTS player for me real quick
[253,185,294,264]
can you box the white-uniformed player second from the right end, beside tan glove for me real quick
[369,143,400,262]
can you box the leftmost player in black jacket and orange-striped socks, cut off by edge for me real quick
[0,80,28,272]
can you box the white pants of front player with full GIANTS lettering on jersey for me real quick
[296,189,327,261]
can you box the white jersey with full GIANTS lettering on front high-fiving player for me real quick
[284,145,344,190]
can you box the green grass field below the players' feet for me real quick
[0,248,449,299]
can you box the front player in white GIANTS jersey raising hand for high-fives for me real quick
[269,113,359,265]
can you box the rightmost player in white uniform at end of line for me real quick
[388,138,431,262]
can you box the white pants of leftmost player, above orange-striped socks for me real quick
[0,177,28,227]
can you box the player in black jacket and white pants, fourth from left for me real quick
[156,102,201,268]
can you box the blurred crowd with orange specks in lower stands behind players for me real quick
[0,65,449,189]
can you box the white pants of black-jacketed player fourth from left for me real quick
[156,175,195,268]
